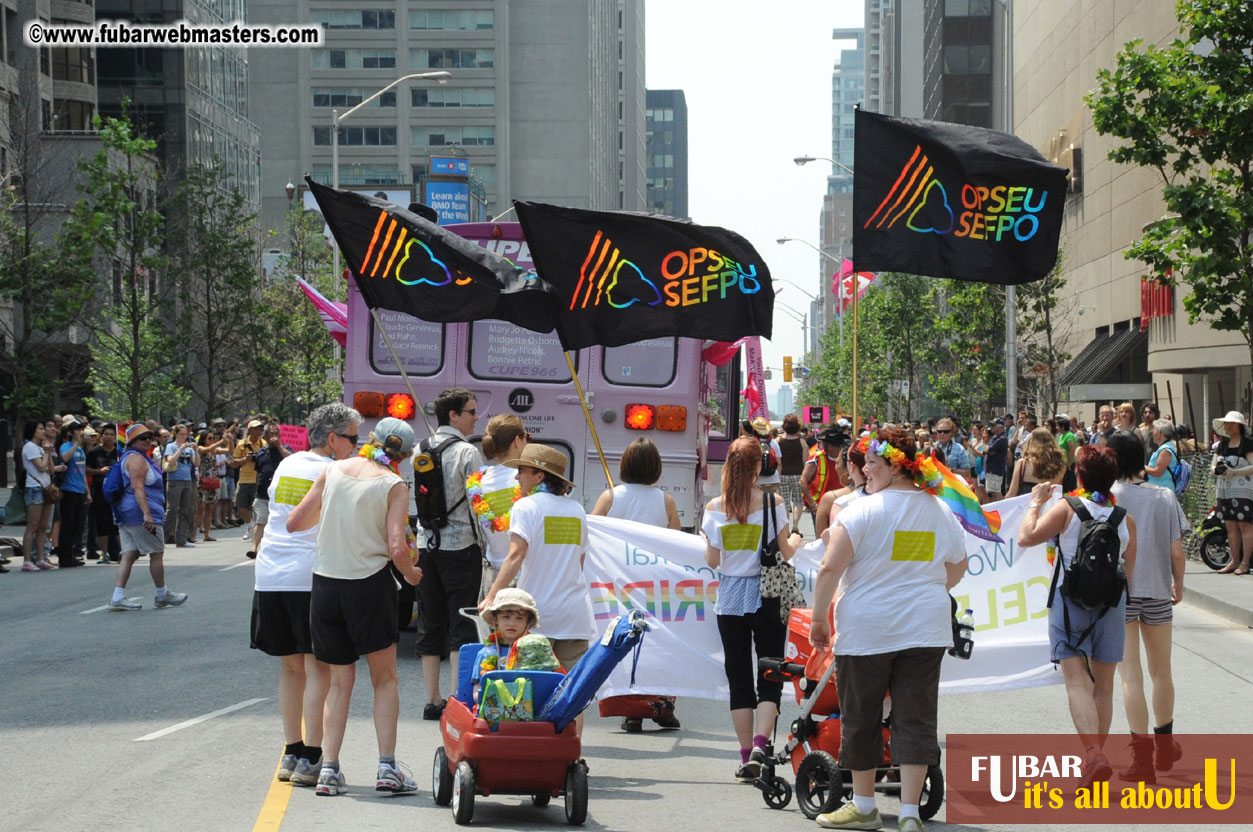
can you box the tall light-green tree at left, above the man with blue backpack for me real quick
[69,113,188,419]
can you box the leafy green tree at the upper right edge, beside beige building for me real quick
[1085,0,1253,403]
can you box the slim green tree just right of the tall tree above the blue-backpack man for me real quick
[168,158,261,415]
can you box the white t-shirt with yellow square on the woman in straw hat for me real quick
[509,491,596,639]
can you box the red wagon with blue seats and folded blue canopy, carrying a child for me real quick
[431,610,648,826]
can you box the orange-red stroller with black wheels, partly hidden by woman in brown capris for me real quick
[753,609,944,821]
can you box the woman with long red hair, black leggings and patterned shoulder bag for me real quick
[700,437,801,783]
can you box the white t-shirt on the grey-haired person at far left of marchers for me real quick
[256,451,333,593]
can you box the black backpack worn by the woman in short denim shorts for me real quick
[1049,496,1126,650]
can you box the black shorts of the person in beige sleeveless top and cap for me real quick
[309,566,400,664]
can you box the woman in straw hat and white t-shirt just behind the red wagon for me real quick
[479,442,596,671]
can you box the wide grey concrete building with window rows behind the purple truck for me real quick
[248,0,647,234]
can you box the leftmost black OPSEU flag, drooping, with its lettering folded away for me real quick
[304,177,558,332]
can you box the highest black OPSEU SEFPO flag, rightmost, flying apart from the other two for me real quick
[853,110,1066,284]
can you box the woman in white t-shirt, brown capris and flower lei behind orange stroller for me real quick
[809,429,966,829]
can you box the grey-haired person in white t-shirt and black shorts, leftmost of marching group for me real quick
[251,402,361,786]
